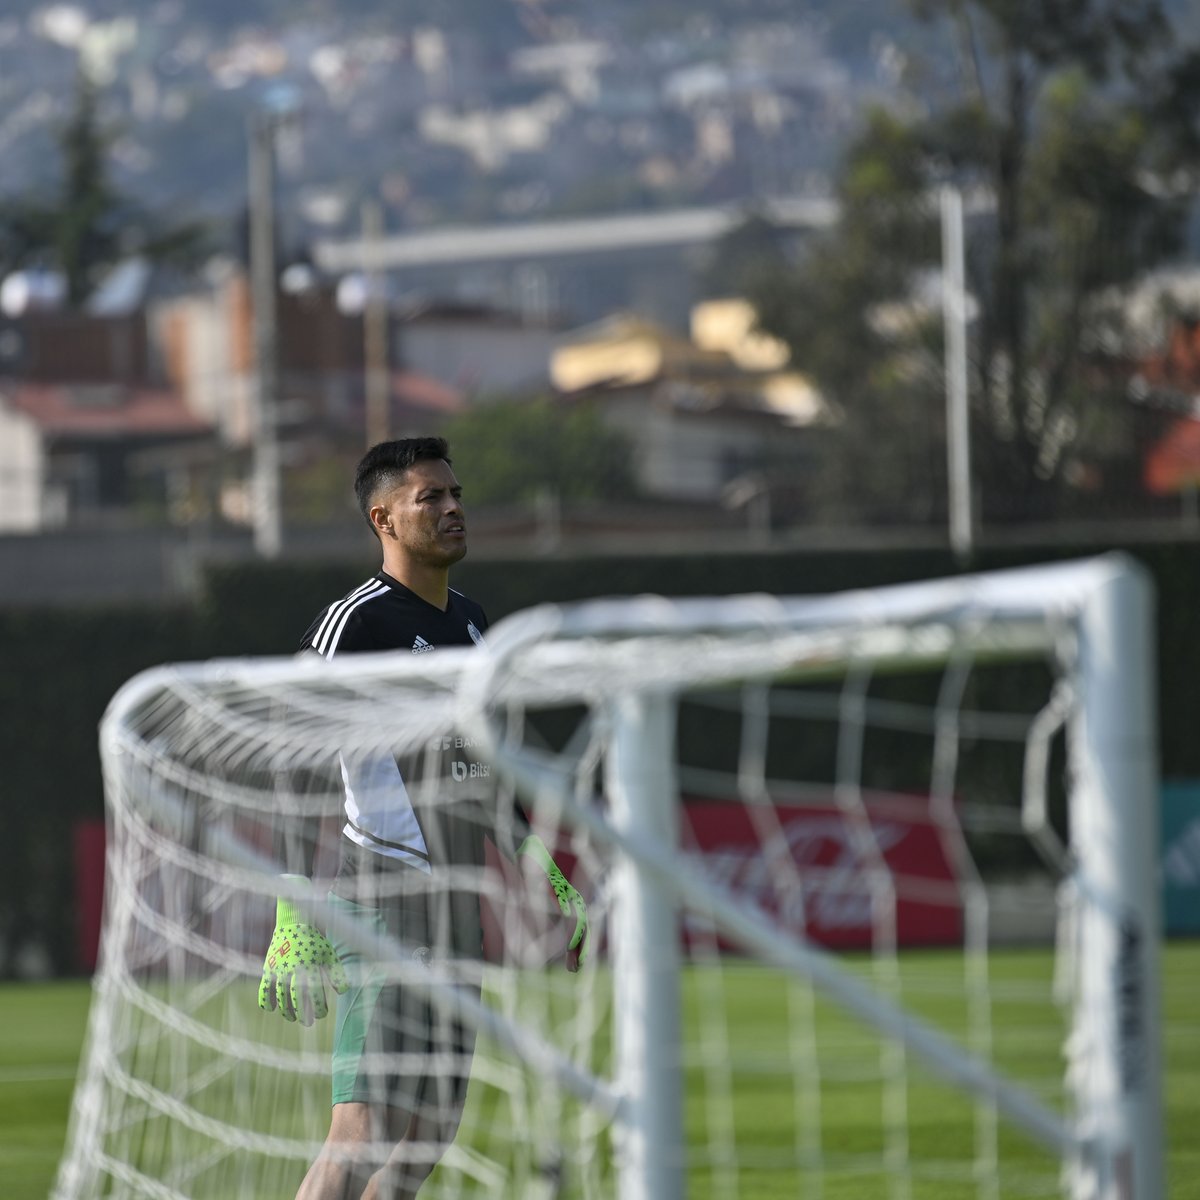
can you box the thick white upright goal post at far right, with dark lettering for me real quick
[1069,552,1165,1195]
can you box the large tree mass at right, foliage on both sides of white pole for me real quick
[756,0,1200,525]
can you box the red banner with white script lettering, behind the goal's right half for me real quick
[683,794,962,949]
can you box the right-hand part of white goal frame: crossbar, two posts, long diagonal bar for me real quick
[464,553,1165,1200]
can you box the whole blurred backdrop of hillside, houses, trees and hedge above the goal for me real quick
[0,0,1200,977]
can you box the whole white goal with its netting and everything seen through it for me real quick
[55,556,1164,1200]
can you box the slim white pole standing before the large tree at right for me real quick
[941,185,974,563]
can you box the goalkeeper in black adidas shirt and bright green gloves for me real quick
[259,438,588,1200]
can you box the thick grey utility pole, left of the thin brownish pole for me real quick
[248,112,283,558]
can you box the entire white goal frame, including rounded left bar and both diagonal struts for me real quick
[55,554,1165,1200]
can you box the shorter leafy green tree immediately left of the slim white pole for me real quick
[750,110,944,522]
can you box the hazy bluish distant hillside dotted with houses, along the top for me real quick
[0,0,892,235]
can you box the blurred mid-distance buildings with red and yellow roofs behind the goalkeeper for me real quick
[0,249,828,556]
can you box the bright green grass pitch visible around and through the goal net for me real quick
[7,942,1200,1200]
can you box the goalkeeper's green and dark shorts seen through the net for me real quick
[330,866,480,1116]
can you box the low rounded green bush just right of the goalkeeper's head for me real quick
[445,398,634,505]
